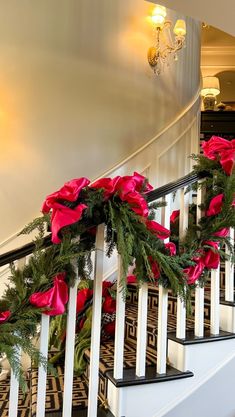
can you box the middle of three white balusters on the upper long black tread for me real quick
[194,184,204,337]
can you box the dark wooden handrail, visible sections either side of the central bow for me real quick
[0,173,201,267]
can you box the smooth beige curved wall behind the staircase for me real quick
[0,0,200,242]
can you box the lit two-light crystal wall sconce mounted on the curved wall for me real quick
[148,4,186,75]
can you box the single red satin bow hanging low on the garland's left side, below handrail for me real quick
[29,273,69,316]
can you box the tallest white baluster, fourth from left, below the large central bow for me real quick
[87,224,104,417]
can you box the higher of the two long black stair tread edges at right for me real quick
[167,330,235,345]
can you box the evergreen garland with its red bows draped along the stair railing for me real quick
[0,137,235,377]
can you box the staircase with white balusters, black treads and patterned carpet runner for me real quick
[0,172,235,417]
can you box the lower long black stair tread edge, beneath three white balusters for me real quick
[106,366,194,388]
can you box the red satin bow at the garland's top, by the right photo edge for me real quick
[202,136,235,175]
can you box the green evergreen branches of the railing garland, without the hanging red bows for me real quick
[0,137,235,383]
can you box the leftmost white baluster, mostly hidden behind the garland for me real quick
[8,258,25,417]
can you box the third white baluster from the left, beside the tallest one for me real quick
[62,268,78,417]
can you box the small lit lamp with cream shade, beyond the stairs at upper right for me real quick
[201,76,220,111]
